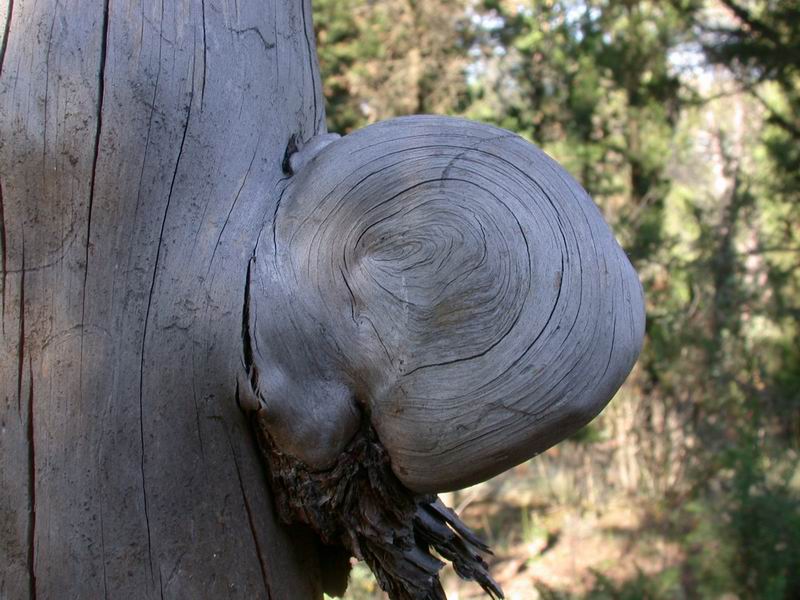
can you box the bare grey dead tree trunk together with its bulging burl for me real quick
[0,0,644,600]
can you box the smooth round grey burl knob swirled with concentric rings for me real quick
[250,117,644,491]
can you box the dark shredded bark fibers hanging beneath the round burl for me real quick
[254,411,503,600]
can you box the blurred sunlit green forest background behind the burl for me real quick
[314,0,800,600]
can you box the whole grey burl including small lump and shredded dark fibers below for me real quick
[240,117,644,599]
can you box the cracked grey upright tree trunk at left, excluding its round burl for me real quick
[0,0,324,599]
